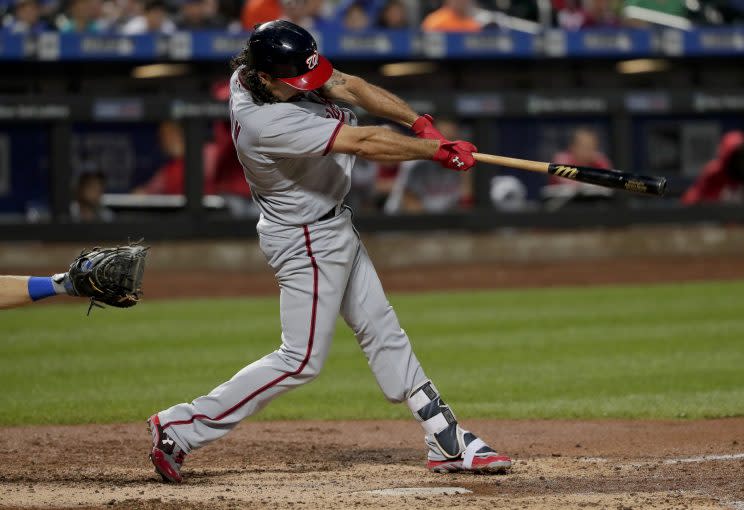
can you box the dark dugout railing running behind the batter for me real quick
[0,90,744,241]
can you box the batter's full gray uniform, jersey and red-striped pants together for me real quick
[158,68,434,453]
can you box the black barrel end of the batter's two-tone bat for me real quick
[548,163,666,196]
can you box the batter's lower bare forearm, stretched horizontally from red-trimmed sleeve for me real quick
[334,127,439,163]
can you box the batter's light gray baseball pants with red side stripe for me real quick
[158,205,427,453]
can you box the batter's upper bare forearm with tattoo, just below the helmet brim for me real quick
[324,71,418,126]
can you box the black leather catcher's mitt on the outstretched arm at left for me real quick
[65,243,149,314]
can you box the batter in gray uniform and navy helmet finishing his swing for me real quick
[148,21,511,482]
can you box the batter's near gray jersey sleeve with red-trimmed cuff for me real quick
[256,103,343,158]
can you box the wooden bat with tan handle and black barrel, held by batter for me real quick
[473,152,666,196]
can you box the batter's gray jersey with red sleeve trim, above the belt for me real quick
[230,67,357,225]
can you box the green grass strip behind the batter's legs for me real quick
[0,282,744,425]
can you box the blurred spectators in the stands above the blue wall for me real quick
[0,0,744,35]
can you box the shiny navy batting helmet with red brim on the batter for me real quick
[247,20,333,90]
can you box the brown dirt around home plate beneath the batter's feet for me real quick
[0,418,744,509]
